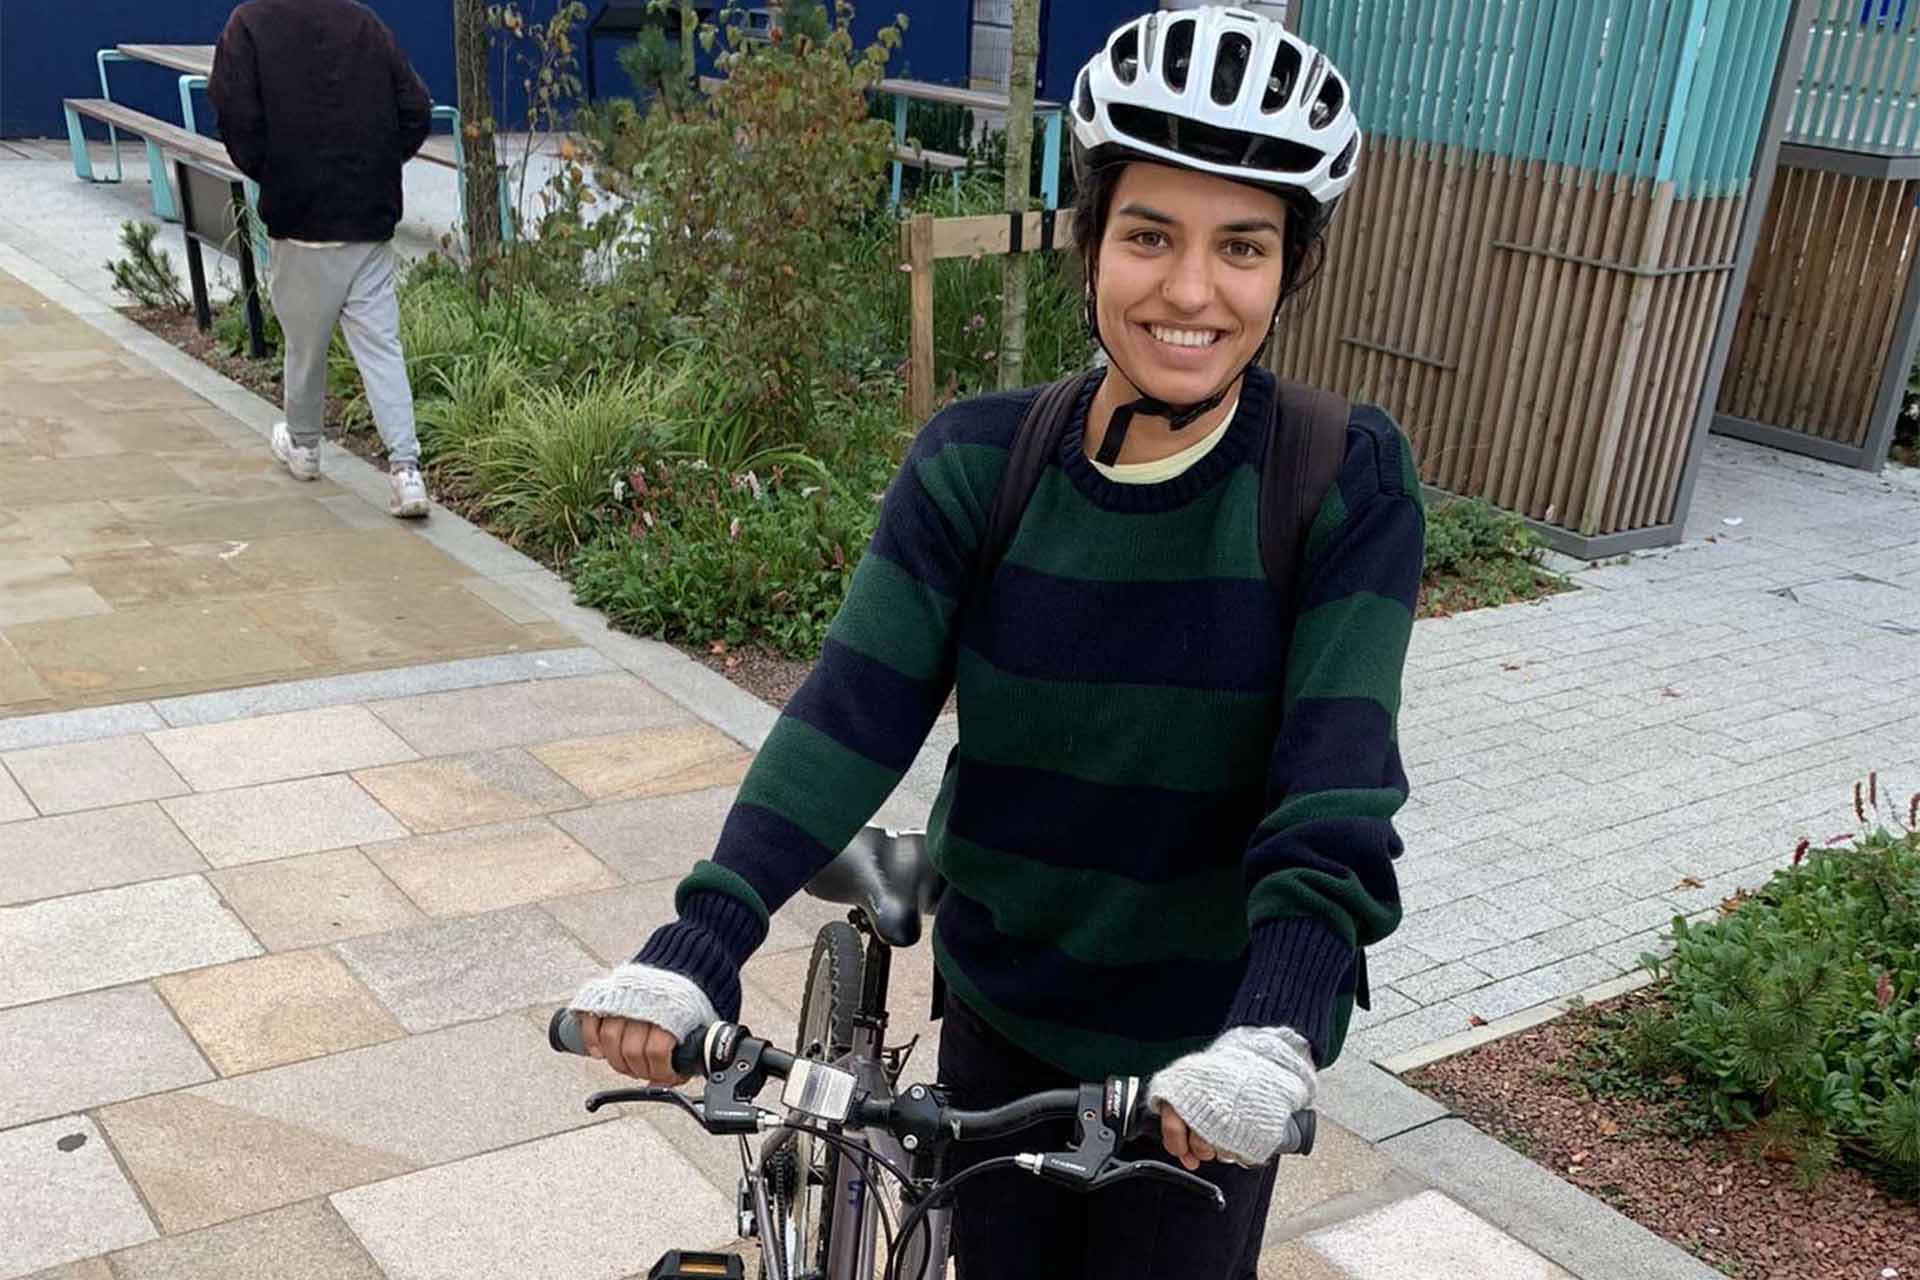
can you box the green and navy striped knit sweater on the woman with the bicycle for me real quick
[636,370,1425,1079]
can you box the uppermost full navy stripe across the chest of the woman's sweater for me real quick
[966,560,1286,693]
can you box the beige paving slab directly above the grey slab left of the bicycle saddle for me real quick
[363,821,620,915]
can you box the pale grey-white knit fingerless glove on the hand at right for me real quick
[1146,1027,1317,1165]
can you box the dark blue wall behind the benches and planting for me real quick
[0,0,1158,138]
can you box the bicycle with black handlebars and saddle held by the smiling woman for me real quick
[547,827,1315,1280]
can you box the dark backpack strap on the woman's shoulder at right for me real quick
[1260,380,1354,616]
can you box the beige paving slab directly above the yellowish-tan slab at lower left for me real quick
[207,848,426,952]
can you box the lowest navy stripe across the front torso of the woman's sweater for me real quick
[939,889,1246,1042]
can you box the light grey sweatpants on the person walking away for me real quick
[273,240,420,466]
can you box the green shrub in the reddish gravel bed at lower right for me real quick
[1622,809,1920,1197]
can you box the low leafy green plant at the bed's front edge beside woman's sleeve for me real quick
[572,461,891,658]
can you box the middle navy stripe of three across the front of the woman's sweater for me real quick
[947,756,1265,883]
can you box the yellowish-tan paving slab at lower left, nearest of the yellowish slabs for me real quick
[154,950,405,1075]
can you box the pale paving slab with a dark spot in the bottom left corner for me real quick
[0,1115,156,1280]
